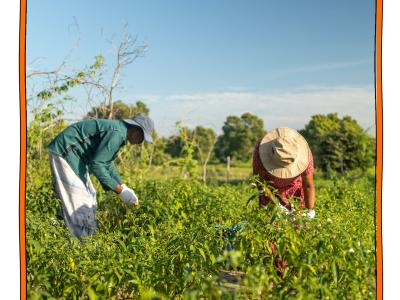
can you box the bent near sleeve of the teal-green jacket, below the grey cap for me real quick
[89,130,124,190]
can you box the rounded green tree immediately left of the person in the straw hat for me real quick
[215,113,265,161]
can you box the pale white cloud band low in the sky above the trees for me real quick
[127,86,375,135]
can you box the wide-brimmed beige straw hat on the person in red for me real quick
[259,127,309,178]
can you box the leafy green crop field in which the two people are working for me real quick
[26,170,375,299]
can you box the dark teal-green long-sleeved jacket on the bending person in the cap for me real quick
[48,119,128,190]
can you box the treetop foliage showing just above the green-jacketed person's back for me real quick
[85,100,149,120]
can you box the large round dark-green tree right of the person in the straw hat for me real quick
[300,113,375,172]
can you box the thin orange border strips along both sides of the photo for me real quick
[19,0,383,300]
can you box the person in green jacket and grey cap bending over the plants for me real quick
[48,114,154,238]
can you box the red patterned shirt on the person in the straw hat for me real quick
[253,139,314,209]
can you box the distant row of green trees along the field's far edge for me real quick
[28,100,375,176]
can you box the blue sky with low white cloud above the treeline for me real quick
[27,0,375,135]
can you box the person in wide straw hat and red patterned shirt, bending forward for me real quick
[253,127,315,219]
